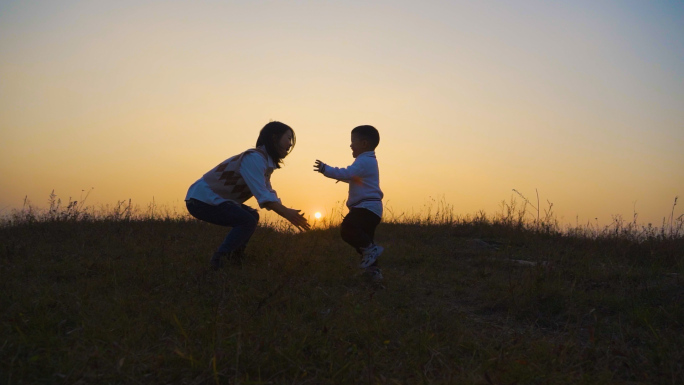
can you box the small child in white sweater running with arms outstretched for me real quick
[314,126,383,281]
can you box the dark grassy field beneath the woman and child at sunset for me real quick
[0,196,684,385]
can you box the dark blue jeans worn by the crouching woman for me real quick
[185,199,259,253]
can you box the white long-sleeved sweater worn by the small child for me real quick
[323,151,383,218]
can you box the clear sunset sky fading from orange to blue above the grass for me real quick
[0,0,684,225]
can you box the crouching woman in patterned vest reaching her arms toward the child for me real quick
[185,122,309,269]
